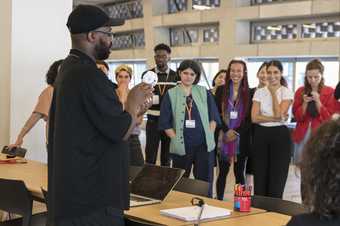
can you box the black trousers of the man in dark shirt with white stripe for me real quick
[145,118,170,166]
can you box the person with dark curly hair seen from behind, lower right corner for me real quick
[287,119,340,226]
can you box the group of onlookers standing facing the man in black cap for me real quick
[12,41,339,200]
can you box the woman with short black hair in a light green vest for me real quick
[159,60,220,196]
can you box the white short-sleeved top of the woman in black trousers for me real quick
[253,86,294,127]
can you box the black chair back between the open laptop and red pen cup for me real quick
[174,177,209,197]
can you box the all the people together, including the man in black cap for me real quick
[11,5,340,226]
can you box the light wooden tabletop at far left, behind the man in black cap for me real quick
[0,154,47,198]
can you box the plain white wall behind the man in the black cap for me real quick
[10,0,72,162]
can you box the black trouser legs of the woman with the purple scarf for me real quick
[216,151,247,200]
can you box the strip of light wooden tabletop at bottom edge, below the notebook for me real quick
[201,212,291,226]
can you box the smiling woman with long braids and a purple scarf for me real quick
[215,60,251,200]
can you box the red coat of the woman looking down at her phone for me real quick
[293,86,336,143]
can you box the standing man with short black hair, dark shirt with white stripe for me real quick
[142,43,178,166]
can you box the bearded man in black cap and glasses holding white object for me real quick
[48,5,152,226]
